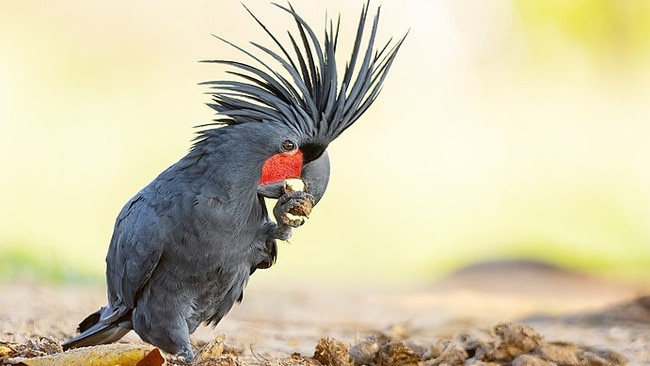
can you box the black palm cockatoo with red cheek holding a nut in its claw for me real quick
[62,2,408,362]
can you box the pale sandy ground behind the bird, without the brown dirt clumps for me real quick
[0,262,650,365]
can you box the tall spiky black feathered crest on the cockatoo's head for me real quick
[197,3,406,142]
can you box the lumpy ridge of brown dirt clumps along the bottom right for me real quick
[350,323,627,366]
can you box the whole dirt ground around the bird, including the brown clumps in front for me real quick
[0,261,650,365]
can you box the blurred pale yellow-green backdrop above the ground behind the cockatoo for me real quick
[0,0,650,283]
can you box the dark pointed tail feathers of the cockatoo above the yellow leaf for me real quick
[61,307,131,351]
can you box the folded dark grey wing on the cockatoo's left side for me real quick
[106,192,169,310]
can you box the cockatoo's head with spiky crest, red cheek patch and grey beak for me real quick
[198,0,404,202]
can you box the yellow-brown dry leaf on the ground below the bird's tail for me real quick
[9,343,165,366]
